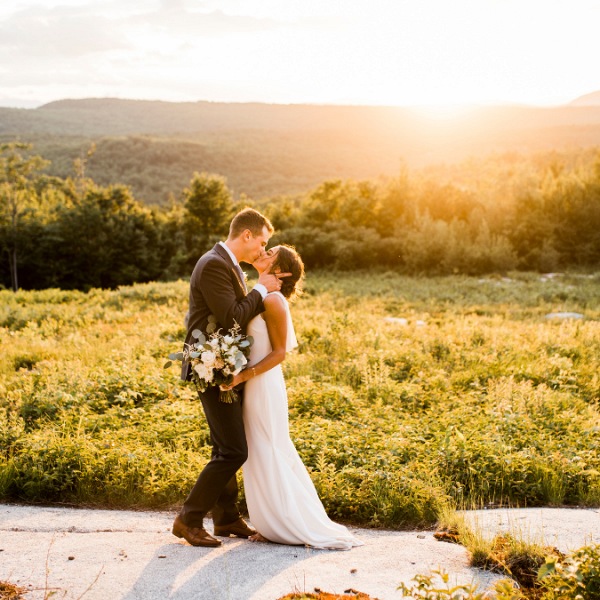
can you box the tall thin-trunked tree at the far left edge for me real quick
[0,142,50,292]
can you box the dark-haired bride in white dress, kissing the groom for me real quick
[220,246,362,550]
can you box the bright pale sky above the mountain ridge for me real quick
[0,0,600,108]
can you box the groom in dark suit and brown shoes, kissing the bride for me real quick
[173,208,289,547]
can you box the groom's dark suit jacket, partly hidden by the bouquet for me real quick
[181,244,265,380]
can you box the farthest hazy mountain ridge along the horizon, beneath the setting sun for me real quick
[0,97,600,138]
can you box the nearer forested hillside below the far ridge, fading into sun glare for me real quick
[0,131,401,205]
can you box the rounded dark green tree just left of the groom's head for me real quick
[183,173,233,266]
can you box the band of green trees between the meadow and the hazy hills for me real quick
[0,142,600,290]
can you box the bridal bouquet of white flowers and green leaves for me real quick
[165,315,254,403]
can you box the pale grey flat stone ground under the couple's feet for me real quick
[0,504,600,600]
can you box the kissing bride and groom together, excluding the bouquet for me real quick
[173,208,362,550]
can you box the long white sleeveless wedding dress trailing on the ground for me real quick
[243,292,362,550]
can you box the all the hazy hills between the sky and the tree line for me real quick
[0,97,600,203]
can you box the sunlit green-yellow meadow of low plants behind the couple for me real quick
[0,271,600,528]
